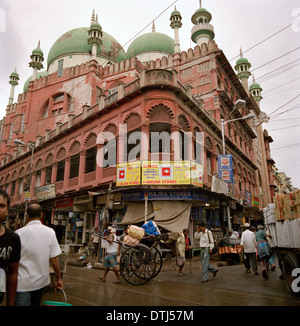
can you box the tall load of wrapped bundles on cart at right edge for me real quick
[263,190,300,248]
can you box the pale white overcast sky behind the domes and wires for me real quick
[0,0,300,188]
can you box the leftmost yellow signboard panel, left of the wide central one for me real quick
[116,162,141,186]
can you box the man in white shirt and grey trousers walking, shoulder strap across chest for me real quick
[197,222,219,283]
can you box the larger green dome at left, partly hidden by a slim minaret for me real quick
[47,27,126,67]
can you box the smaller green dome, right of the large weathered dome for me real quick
[127,32,174,58]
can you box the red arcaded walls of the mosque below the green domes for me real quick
[0,41,263,243]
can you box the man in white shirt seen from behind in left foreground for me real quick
[15,203,63,306]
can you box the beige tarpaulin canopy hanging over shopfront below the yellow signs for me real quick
[121,201,192,232]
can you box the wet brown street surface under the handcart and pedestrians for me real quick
[43,261,300,307]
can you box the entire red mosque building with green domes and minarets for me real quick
[0,2,272,246]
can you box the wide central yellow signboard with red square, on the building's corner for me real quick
[142,161,191,185]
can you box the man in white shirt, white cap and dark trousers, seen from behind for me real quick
[241,223,258,275]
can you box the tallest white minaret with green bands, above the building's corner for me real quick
[192,0,215,46]
